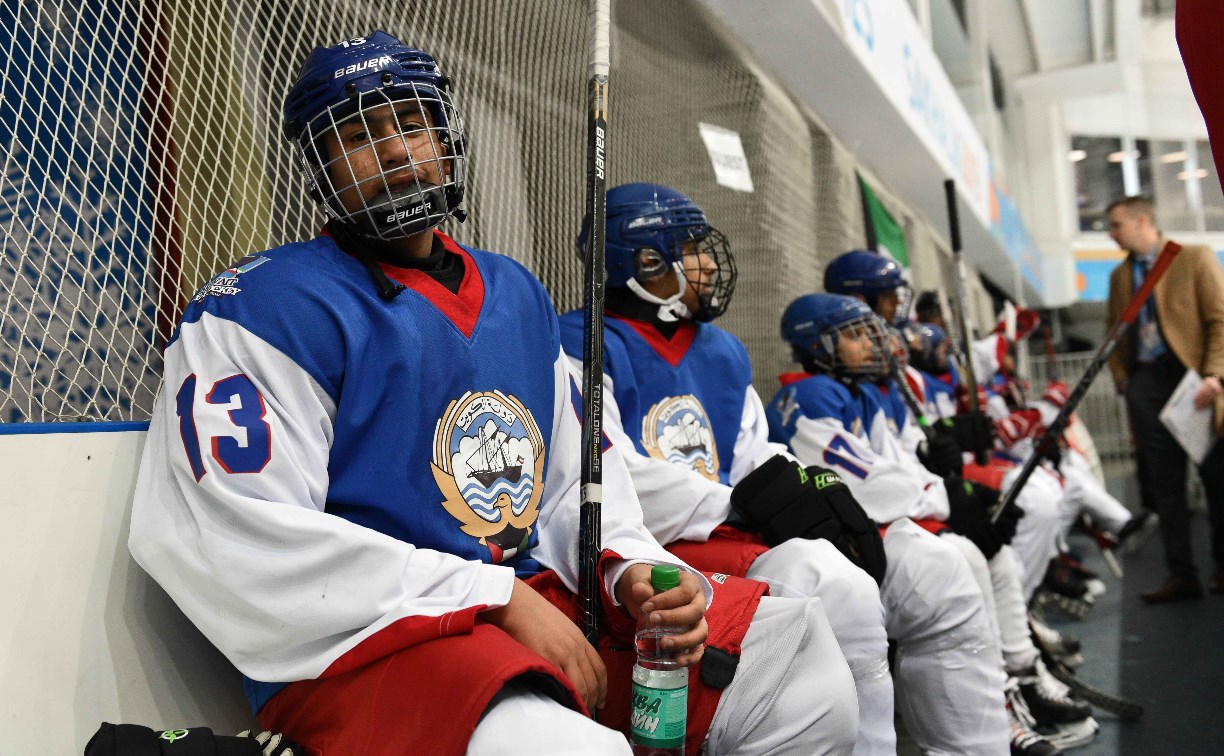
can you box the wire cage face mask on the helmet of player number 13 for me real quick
[297,83,466,241]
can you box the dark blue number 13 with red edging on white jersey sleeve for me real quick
[175,373,272,481]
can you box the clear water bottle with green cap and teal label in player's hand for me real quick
[629,564,688,756]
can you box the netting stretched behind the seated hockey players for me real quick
[0,0,993,422]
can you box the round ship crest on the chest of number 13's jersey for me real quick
[430,391,545,564]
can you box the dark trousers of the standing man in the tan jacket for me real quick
[1126,355,1224,580]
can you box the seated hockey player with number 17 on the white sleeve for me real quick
[765,294,1042,754]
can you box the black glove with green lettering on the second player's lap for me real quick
[731,455,887,585]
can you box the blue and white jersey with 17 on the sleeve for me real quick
[765,374,949,525]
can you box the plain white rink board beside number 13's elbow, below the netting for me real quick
[0,424,255,755]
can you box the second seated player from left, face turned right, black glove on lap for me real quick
[561,183,896,755]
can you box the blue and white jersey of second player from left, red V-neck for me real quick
[561,311,785,543]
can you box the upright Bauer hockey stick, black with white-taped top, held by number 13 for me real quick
[578,0,612,647]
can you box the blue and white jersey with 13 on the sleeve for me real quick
[129,234,695,708]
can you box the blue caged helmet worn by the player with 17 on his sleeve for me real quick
[782,294,889,379]
